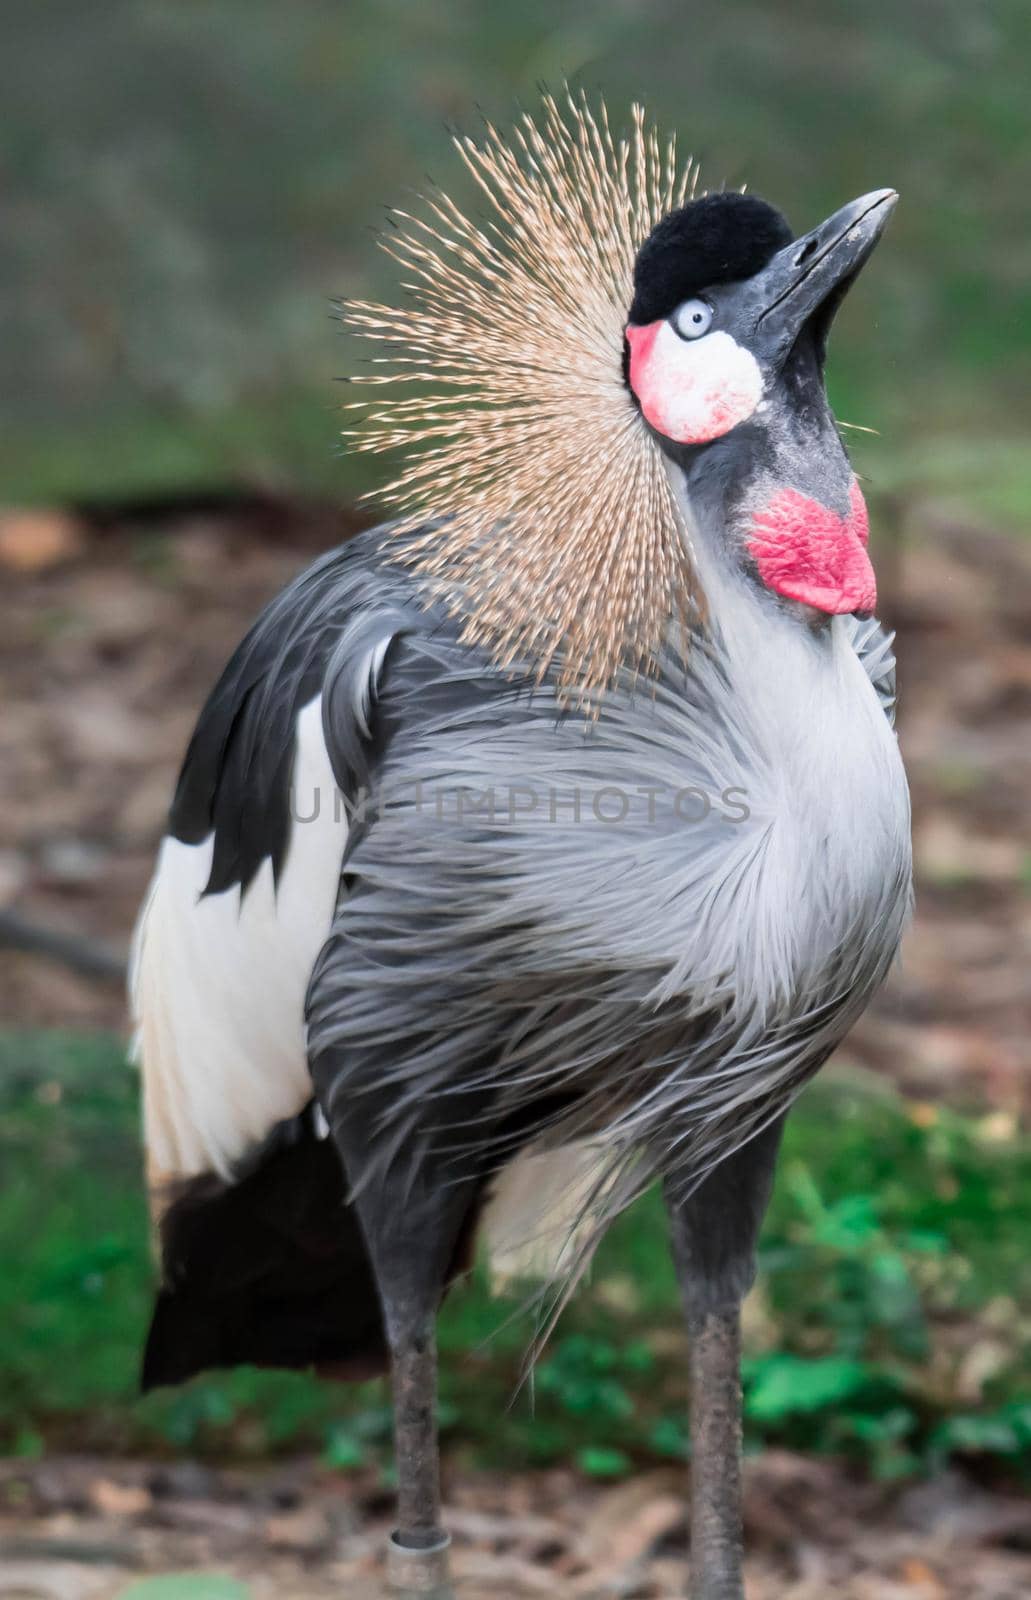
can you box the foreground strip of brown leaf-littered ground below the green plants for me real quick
[0,1451,1031,1600]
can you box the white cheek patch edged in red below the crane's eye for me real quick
[626,320,762,445]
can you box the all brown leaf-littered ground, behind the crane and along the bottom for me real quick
[0,499,1031,1600]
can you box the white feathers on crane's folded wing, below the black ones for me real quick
[130,698,347,1184]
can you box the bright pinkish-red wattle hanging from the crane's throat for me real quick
[748,478,877,614]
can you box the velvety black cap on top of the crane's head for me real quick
[629,194,794,325]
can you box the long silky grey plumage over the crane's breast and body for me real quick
[295,512,909,1205]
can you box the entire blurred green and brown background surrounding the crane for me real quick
[0,0,1031,1600]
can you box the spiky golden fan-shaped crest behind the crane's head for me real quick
[341,93,701,704]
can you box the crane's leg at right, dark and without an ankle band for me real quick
[666,1123,781,1600]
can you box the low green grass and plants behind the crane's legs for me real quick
[0,1034,1031,1477]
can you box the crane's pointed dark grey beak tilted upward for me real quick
[749,189,898,355]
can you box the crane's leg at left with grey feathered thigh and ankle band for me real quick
[307,915,496,1600]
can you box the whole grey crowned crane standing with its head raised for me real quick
[133,98,911,1600]
